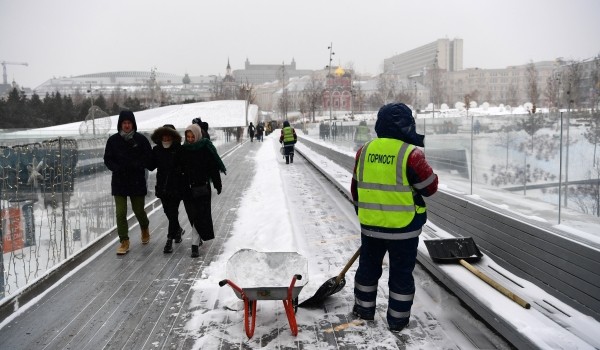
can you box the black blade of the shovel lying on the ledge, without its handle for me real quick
[423,237,483,263]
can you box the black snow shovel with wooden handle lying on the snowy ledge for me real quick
[423,237,531,309]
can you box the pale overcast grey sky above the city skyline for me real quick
[0,0,600,88]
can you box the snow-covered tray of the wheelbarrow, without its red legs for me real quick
[226,249,308,300]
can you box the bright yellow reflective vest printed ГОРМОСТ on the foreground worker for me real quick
[355,138,424,229]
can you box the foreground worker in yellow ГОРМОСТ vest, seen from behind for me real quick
[351,103,438,332]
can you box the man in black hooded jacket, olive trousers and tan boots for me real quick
[104,111,152,255]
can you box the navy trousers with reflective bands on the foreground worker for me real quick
[354,235,419,325]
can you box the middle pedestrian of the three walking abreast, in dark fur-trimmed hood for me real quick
[149,124,185,254]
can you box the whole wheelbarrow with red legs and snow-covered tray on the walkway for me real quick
[219,249,308,338]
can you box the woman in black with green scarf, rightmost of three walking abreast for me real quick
[177,124,226,258]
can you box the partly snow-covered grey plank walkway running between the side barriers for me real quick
[0,136,509,349]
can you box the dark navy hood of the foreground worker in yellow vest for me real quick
[375,103,425,147]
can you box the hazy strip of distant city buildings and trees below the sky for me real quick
[0,39,600,115]
